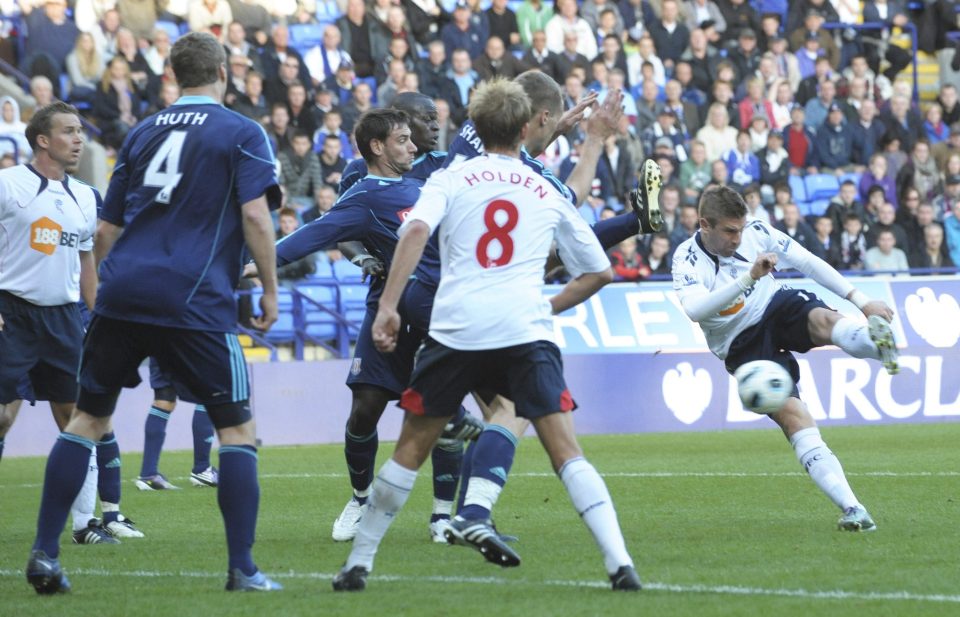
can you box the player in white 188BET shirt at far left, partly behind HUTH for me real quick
[0,102,142,544]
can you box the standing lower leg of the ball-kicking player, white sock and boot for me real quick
[770,398,877,531]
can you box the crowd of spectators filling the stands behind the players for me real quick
[0,0,960,280]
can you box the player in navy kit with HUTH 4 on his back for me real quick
[26,32,281,594]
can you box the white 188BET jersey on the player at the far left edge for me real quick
[0,165,101,306]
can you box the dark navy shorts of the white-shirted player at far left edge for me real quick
[0,291,83,405]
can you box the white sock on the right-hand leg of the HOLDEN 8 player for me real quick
[560,457,633,574]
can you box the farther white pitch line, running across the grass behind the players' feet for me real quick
[0,471,960,489]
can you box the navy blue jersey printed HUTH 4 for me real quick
[95,96,280,332]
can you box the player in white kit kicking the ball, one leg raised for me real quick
[673,186,898,531]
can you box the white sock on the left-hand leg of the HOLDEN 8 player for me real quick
[346,459,417,571]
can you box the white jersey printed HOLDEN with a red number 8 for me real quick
[404,154,610,350]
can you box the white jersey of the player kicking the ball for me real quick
[673,220,812,359]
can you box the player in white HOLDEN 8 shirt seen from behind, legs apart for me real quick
[333,80,640,591]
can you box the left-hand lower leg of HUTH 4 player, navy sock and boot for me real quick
[26,433,96,594]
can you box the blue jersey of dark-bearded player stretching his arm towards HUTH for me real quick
[277,175,440,305]
